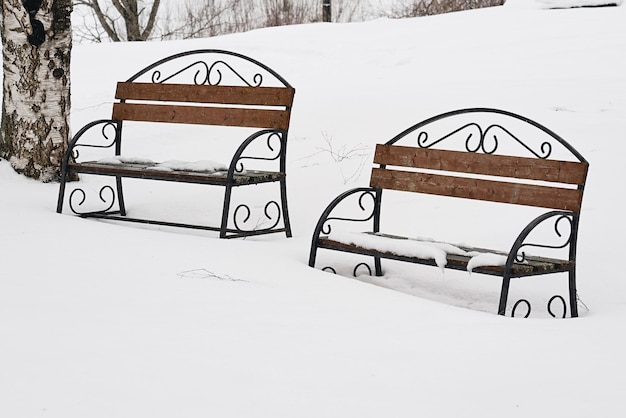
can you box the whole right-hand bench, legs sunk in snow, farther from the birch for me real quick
[309,108,588,317]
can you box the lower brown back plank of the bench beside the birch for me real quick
[112,103,289,130]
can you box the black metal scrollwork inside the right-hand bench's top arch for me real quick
[417,122,552,159]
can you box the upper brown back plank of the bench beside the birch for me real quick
[115,82,295,106]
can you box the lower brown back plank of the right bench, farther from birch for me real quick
[370,168,582,212]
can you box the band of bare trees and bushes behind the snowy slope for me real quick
[73,0,505,42]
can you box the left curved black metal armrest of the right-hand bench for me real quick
[309,187,381,267]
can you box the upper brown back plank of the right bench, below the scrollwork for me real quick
[374,144,589,185]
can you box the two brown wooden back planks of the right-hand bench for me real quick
[370,145,588,212]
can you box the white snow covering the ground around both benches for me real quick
[0,0,626,418]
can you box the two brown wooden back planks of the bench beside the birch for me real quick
[112,83,294,130]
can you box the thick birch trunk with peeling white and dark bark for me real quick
[0,0,73,182]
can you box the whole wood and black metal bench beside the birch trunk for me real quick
[57,50,295,238]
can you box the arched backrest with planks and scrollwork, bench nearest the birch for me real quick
[112,50,295,131]
